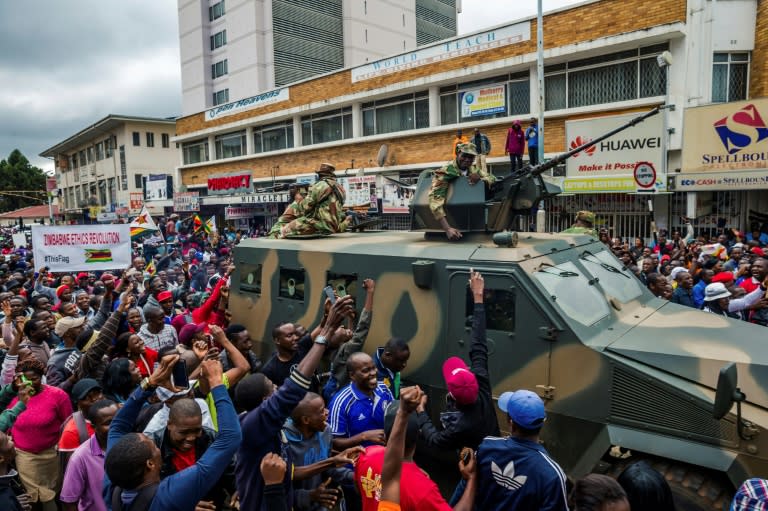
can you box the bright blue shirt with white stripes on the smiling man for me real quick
[328,382,393,446]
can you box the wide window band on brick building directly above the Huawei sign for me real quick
[544,43,668,110]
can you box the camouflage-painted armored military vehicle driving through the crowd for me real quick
[230,108,768,509]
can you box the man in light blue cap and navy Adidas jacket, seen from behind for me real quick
[475,390,568,511]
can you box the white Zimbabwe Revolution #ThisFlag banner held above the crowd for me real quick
[32,224,131,273]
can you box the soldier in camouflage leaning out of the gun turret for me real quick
[429,144,496,240]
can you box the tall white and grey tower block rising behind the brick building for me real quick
[178,0,456,114]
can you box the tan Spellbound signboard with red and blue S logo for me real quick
[680,98,768,173]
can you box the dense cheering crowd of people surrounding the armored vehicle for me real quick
[0,212,768,511]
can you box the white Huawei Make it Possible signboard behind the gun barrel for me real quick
[563,114,666,193]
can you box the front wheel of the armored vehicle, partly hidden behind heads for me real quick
[595,454,734,511]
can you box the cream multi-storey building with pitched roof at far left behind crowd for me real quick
[40,115,178,219]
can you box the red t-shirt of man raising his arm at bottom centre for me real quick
[355,445,452,511]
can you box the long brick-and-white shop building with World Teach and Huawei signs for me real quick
[174,0,768,237]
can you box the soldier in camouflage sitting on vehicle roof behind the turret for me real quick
[278,163,349,238]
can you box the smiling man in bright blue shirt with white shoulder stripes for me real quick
[329,352,392,451]
